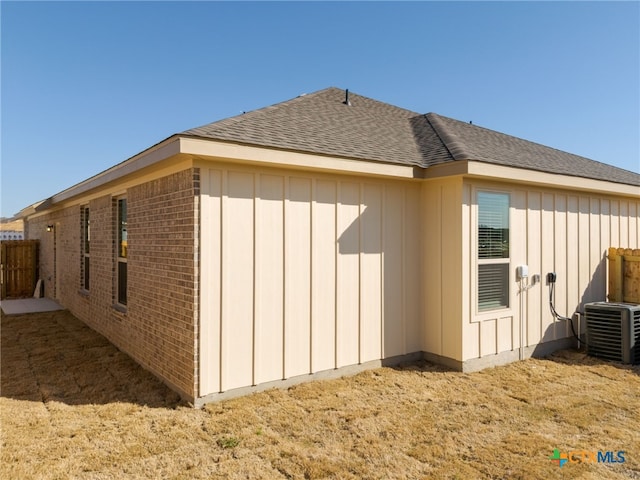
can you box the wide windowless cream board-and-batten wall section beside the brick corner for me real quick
[199,166,421,397]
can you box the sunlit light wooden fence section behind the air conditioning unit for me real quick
[607,247,640,304]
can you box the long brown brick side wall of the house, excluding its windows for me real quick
[28,169,199,398]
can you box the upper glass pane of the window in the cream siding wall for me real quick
[478,192,509,258]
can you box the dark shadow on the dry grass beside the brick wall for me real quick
[1,311,181,408]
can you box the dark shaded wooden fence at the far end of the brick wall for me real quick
[0,240,39,299]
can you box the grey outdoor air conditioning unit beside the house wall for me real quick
[584,302,640,364]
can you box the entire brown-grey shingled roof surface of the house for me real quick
[180,87,640,186]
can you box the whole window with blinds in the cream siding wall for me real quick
[477,192,510,312]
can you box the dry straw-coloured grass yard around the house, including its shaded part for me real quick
[0,312,640,480]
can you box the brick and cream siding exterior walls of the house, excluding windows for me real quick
[25,143,640,404]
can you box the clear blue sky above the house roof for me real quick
[0,1,640,216]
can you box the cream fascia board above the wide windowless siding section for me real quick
[180,137,423,179]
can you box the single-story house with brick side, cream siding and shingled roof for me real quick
[21,88,640,405]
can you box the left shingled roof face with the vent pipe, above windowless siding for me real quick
[182,88,422,166]
